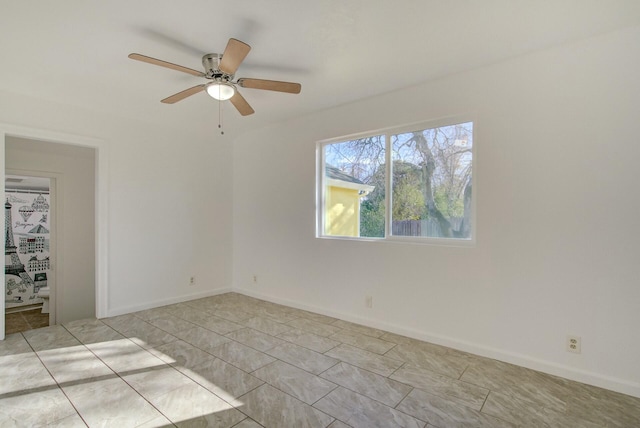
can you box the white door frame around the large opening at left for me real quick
[0,123,109,340]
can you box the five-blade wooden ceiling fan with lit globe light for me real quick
[129,38,302,116]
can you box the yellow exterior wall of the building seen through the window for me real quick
[324,186,360,236]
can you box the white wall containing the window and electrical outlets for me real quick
[233,27,640,396]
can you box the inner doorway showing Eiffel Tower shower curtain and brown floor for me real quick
[4,175,56,334]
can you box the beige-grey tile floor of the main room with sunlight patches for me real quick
[0,293,640,428]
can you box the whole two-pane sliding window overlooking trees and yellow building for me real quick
[318,118,474,242]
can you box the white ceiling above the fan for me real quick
[0,0,640,135]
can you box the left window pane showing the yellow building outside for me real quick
[323,135,385,238]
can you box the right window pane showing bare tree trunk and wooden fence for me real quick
[391,122,473,239]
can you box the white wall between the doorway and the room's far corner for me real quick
[0,92,232,322]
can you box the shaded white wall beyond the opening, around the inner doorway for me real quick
[5,137,96,323]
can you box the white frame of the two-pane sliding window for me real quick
[316,115,478,247]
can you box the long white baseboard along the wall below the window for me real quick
[231,287,640,398]
